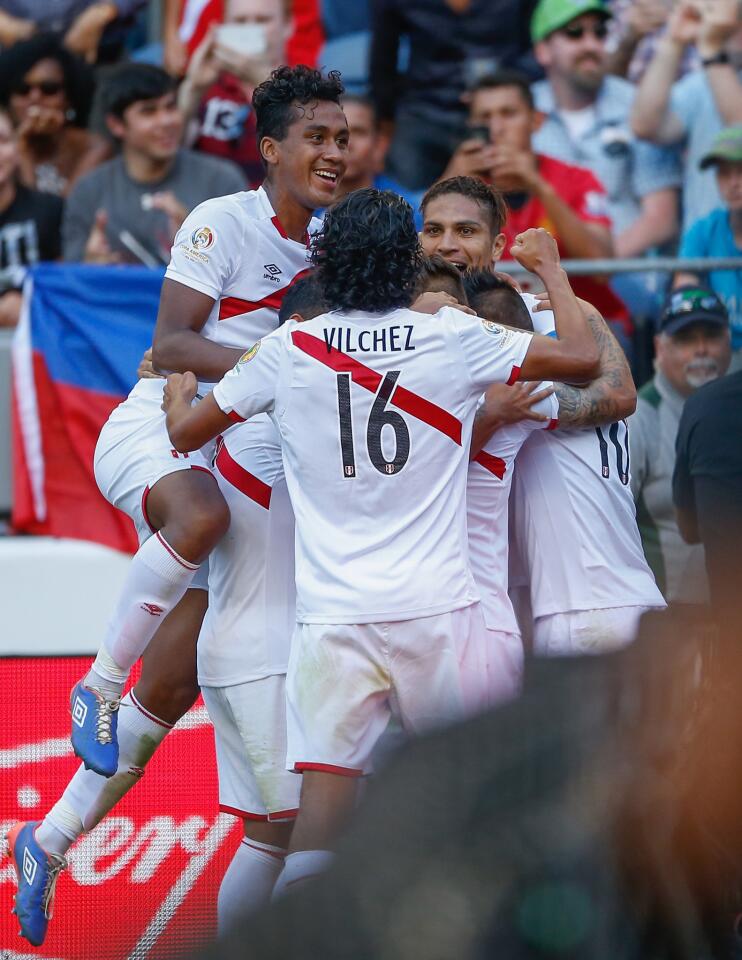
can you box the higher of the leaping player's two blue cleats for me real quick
[70,680,121,777]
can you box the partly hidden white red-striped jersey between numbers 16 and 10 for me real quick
[466,381,559,633]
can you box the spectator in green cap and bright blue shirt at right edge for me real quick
[675,126,742,369]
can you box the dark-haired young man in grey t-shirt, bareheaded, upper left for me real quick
[62,63,244,266]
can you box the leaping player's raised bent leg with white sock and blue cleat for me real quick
[72,469,229,776]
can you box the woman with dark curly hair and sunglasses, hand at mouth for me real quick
[0,34,111,196]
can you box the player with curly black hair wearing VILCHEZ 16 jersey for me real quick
[164,189,598,888]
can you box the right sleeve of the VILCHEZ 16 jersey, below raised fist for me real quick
[448,307,533,395]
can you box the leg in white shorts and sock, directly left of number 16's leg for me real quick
[203,674,300,935]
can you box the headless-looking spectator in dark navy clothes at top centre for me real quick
[370,0,535,190]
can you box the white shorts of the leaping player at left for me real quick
[93,380,211,544]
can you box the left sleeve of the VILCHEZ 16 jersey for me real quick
[213,329,286,423]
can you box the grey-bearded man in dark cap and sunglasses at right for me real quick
[629,285,730,604]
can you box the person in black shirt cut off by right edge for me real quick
[673,371,742,624]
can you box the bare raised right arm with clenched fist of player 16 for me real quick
[510,227,600,382]
